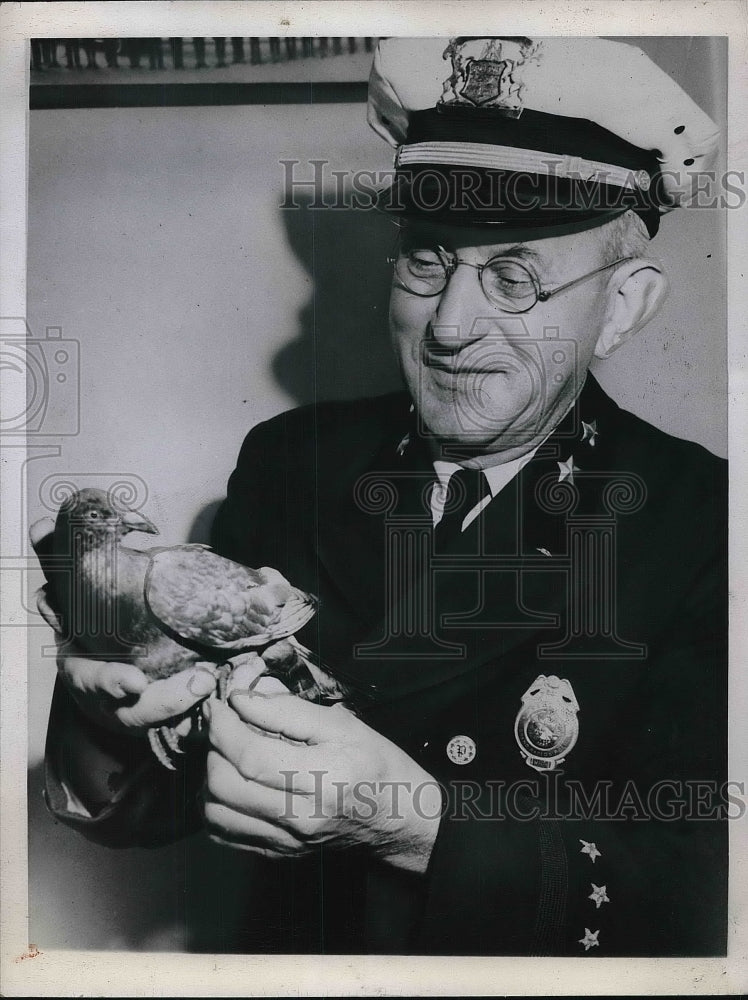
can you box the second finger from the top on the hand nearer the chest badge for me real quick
[203,698,313,791]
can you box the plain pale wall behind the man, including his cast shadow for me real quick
[27,39,726,949]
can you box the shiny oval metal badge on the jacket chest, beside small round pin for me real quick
[514,674,579,771]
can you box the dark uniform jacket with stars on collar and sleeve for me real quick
[47,376,729,956]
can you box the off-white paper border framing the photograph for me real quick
[0,0,748,996]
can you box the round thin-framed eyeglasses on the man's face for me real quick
[387,246,633,313]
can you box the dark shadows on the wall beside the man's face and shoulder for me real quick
[188,195,402,544]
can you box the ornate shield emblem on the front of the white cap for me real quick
[439,38,540,118]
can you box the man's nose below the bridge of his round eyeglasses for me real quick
[431,261,498,350]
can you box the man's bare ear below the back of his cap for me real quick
[595,258,668,358]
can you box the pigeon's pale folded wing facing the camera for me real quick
[144,545,317,653]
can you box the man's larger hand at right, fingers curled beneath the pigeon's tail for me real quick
[204,691,442,873]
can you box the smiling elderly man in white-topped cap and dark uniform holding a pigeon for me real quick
[39,38,727,956]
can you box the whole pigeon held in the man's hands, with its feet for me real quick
[40,488,350,770]
